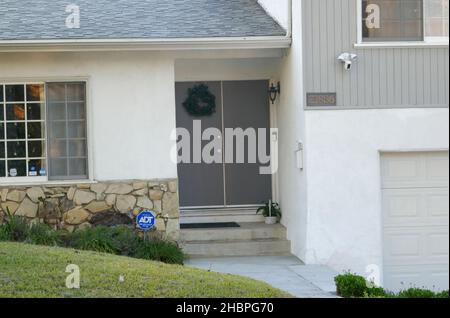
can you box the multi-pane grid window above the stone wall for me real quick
[0,82,88,182]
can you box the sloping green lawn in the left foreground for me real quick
[0,242,291,298]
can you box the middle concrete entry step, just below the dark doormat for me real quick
[181,223,286,242]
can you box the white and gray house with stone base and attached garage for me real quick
[0,0,449,290]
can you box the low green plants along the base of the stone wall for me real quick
[0,215,184,265]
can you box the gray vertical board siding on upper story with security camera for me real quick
[302,0,449,108]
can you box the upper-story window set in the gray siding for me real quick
[358,0,449,43]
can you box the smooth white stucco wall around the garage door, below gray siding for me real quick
[304,109,449,273]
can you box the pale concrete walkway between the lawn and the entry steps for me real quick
[186,256,336,298]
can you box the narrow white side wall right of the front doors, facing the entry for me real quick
[277,1,308,259]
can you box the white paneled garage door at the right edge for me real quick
[382,152,449,291]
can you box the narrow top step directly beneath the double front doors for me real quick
[180,208,264,224]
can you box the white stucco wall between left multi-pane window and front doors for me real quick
[0,52,177,181]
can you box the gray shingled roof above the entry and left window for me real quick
[0,0,286,40]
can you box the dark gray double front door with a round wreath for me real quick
[176,81,272,207]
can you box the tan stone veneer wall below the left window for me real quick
[0,180,180,240]
